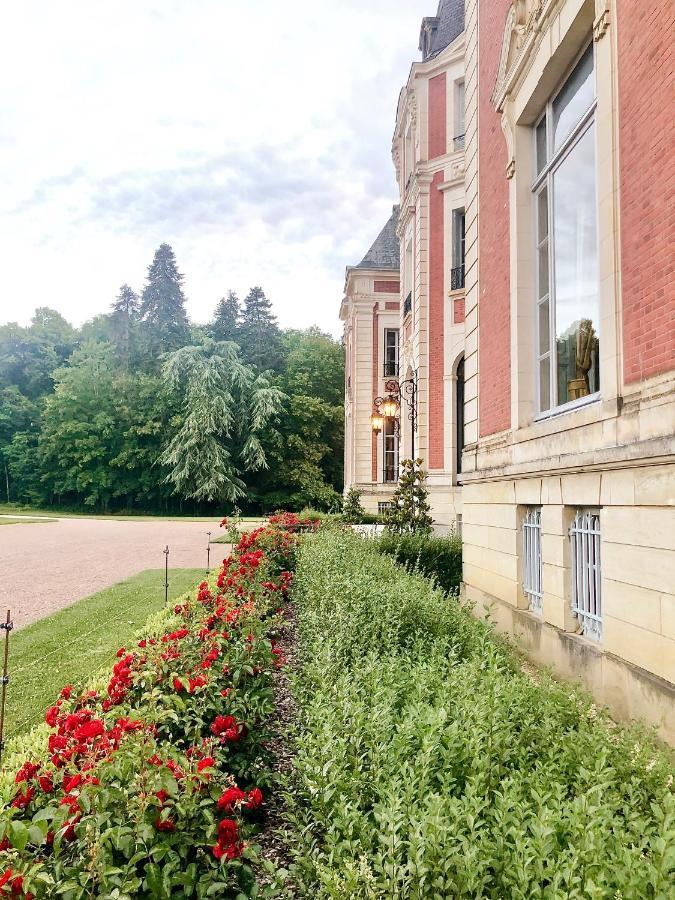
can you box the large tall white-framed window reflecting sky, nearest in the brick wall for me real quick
[533,44,600,412]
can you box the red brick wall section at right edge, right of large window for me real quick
[617,0,675,383]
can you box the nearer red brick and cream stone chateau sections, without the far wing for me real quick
[346,0,675,742]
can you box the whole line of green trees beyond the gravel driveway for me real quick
[0,244,344,512]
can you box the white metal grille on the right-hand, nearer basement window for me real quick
[570,509,602,641]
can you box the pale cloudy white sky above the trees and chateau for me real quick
[0,0,430,334]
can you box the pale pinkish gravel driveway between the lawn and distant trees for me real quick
[0,519,228,627]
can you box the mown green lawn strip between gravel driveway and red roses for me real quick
[5,569,204,738]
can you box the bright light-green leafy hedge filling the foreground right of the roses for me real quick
[287,531,675,900]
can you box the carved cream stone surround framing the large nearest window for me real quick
[493,0,622,432]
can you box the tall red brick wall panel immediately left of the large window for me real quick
[478,0,511,437]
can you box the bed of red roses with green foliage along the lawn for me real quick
[0,526,298,900]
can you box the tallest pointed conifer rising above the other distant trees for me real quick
[140,244,190,357]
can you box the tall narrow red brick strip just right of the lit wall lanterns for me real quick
[429,172,445,469]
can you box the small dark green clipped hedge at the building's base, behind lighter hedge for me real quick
[376,532,462,591]
